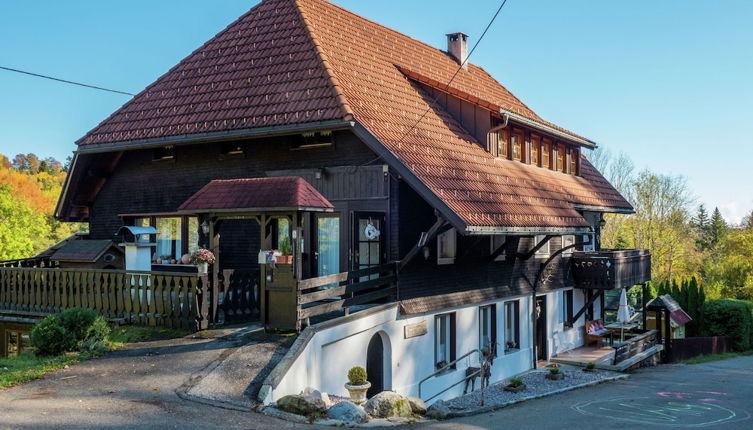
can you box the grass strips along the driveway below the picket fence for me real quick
[0,325,190,389]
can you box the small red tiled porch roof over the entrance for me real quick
[178,176,334,213]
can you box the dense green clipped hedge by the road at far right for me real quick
[702,299,753,351]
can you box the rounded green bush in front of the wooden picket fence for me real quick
[31,308,110,355]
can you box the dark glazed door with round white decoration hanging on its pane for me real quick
[352,212,386,280]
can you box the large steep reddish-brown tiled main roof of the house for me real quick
[79,0,632,229]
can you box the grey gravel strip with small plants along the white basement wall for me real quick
[447,367,621,410]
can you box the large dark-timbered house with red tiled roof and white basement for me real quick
[48,0,650,400]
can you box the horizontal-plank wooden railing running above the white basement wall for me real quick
[298,263,397,320]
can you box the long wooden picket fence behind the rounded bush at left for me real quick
[0,267,208,329]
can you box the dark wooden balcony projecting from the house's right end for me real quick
[570,249,651,290]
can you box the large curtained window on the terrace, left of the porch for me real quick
[132,216,199,264]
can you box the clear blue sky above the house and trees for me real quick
[0,0,753,221]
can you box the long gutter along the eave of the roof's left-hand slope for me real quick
[71,119,353,155]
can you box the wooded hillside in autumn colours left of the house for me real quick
[0,154,84,260]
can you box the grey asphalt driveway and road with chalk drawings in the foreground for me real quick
[0,336,753,430]
